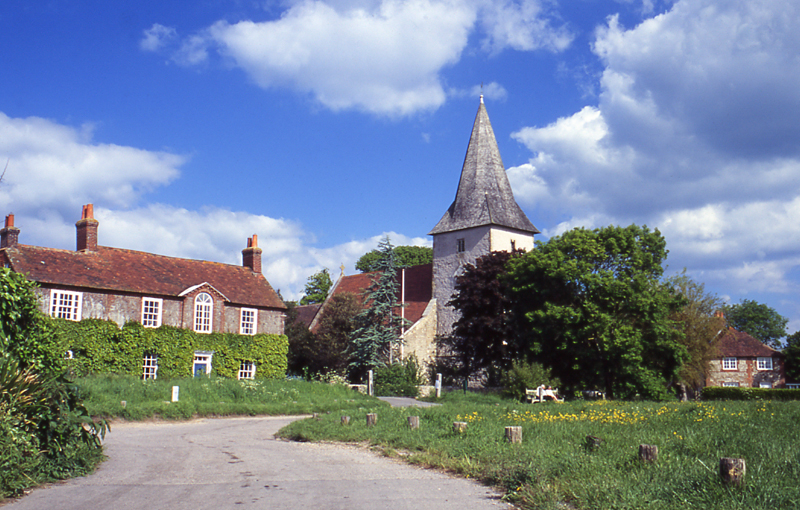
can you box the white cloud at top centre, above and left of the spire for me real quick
[158,0,572,116]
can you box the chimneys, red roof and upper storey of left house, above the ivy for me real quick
[0,204,286,335]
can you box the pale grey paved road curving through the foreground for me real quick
[9,417,509,510]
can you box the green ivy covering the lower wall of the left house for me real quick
[50,319,289,378]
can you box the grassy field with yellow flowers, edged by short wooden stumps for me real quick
[281,394,800,510]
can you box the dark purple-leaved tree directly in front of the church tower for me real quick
[439,251,523,377]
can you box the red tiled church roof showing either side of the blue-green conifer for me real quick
[331,264,433,324]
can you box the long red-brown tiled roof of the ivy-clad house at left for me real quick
[0,244,286,309]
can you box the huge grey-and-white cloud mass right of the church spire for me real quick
[508,0,800,320]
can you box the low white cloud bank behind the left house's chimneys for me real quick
[0,113,430,299]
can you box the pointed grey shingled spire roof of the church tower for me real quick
[428,96,539,235]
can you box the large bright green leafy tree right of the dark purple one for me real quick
[508,225,685,398]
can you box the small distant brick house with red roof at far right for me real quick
[706,328,786,388]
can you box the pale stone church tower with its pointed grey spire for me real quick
[428,95,539,336]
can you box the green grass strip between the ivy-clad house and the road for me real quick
[76,375,387,420]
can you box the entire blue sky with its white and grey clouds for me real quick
[0,0,800,332]
